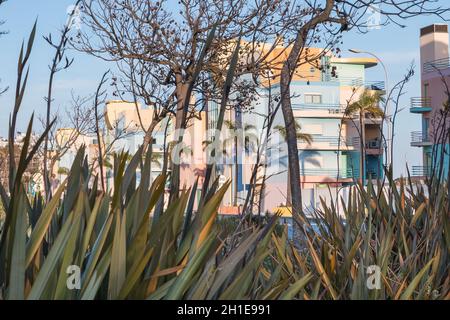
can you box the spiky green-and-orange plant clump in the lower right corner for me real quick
[285,177,450,300]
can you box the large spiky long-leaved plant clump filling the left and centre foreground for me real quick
[1,140,316,299]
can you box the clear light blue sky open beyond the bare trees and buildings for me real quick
[0,0,450,175]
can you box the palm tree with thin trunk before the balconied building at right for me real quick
[345,89,384,184]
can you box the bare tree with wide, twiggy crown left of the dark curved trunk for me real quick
[74,0,310,198]
